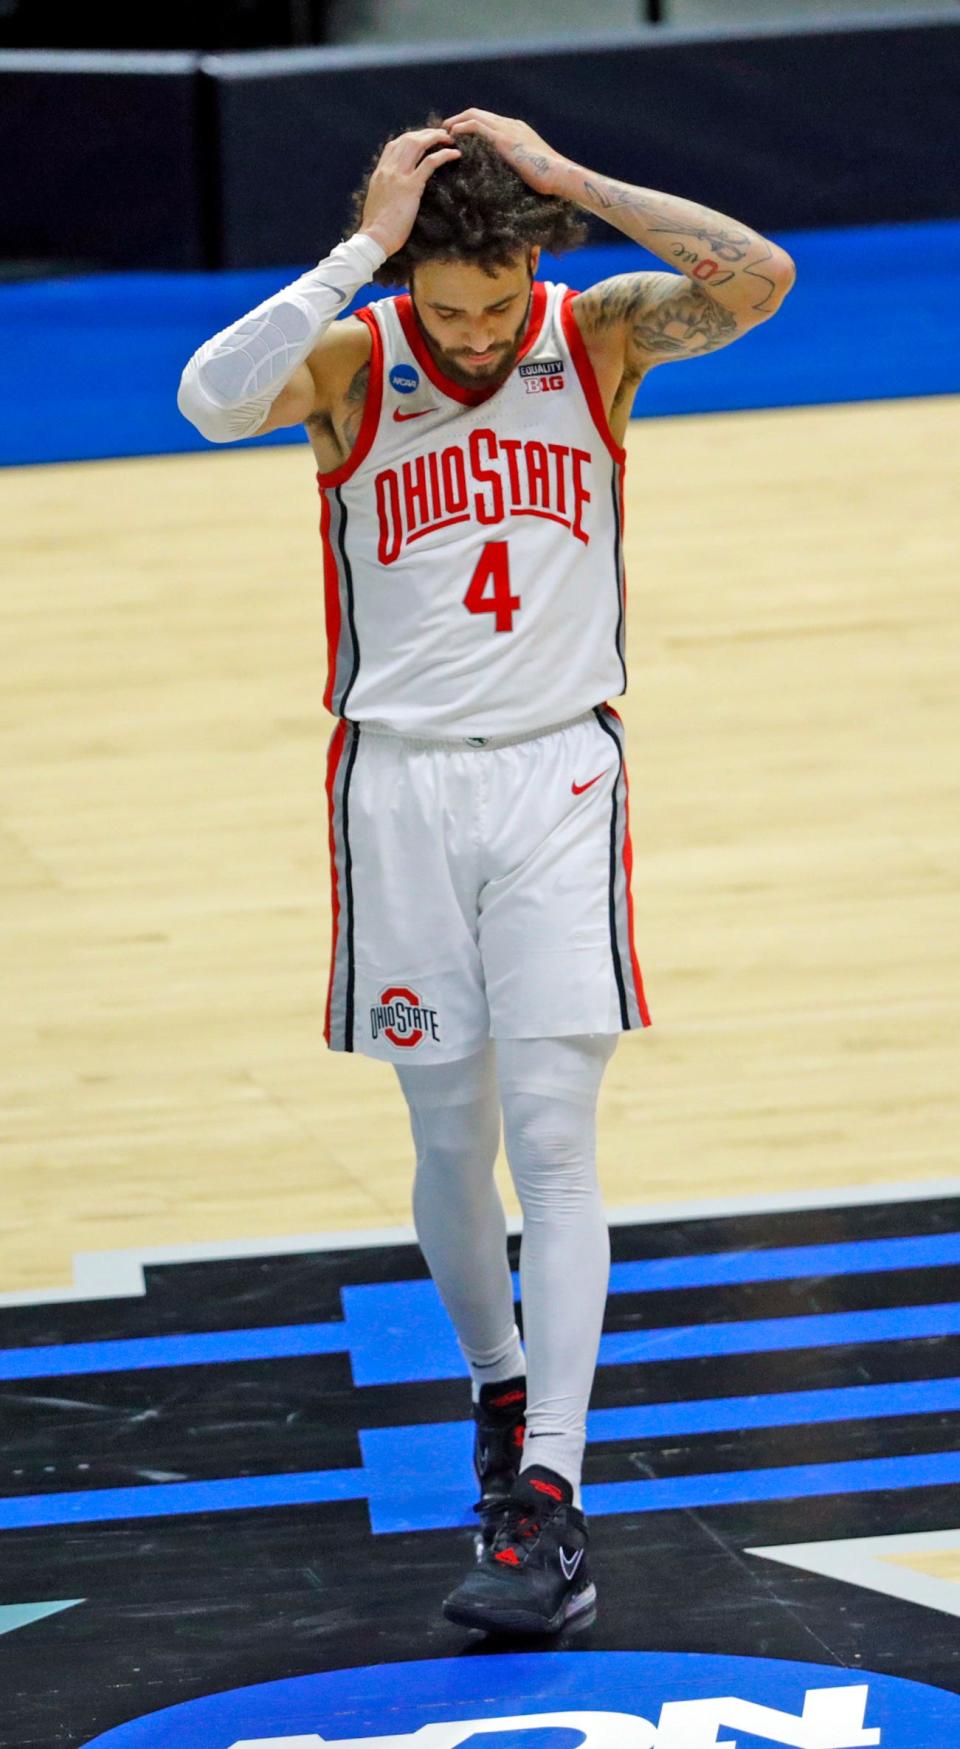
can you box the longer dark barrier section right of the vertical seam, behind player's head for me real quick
[206,19,960,266]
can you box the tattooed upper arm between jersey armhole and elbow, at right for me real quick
[582,273,740,374]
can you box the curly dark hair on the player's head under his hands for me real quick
[348,115,588,285]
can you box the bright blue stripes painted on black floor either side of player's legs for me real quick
[0,1231,960,1536]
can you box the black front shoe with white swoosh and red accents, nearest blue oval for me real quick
[442,1466,596,1634]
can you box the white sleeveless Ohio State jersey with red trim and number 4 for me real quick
[317,282,626,740]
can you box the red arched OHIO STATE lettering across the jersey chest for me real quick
[374,427,593,565]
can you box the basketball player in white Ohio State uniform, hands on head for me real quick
[180,108,794,1634]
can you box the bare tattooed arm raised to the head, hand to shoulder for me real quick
[448,108,796,383]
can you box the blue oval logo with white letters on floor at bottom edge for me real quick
[76,1651,960,1749]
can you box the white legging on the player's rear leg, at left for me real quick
[397,1046,525,1401]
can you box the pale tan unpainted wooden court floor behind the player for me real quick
[0,397,960,1293]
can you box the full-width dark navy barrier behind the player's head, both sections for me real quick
[0,17,960,268]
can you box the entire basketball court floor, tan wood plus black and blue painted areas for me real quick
[0,397,960,1749]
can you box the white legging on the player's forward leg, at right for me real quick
[497,1034,619,1504]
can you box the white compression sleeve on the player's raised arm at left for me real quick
[177,233,386,442]
